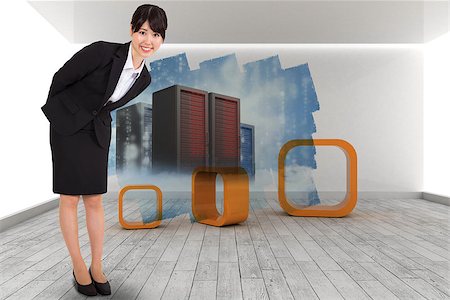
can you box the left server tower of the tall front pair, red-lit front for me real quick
[152,85,209,173]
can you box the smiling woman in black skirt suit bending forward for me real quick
[41,4,167,295]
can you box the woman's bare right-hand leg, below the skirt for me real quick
[83,194,107,282]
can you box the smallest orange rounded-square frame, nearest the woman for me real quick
[119,185,162,229]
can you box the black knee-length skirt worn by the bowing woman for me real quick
[50,121,109,195]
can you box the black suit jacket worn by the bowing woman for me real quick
[41,41,151,149]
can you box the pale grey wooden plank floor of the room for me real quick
[0,193,450,300]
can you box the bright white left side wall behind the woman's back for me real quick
[0,1,81,218]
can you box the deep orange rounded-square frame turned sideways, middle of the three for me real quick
[192,167,250,226]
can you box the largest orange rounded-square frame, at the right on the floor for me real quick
[278,139,358,217]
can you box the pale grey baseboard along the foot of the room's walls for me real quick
[0,191,450,232]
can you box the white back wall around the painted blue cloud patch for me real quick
[160,45,423,192]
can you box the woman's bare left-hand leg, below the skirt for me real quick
[59,194,91,285]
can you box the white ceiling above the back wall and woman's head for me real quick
[28,0,450,44]
